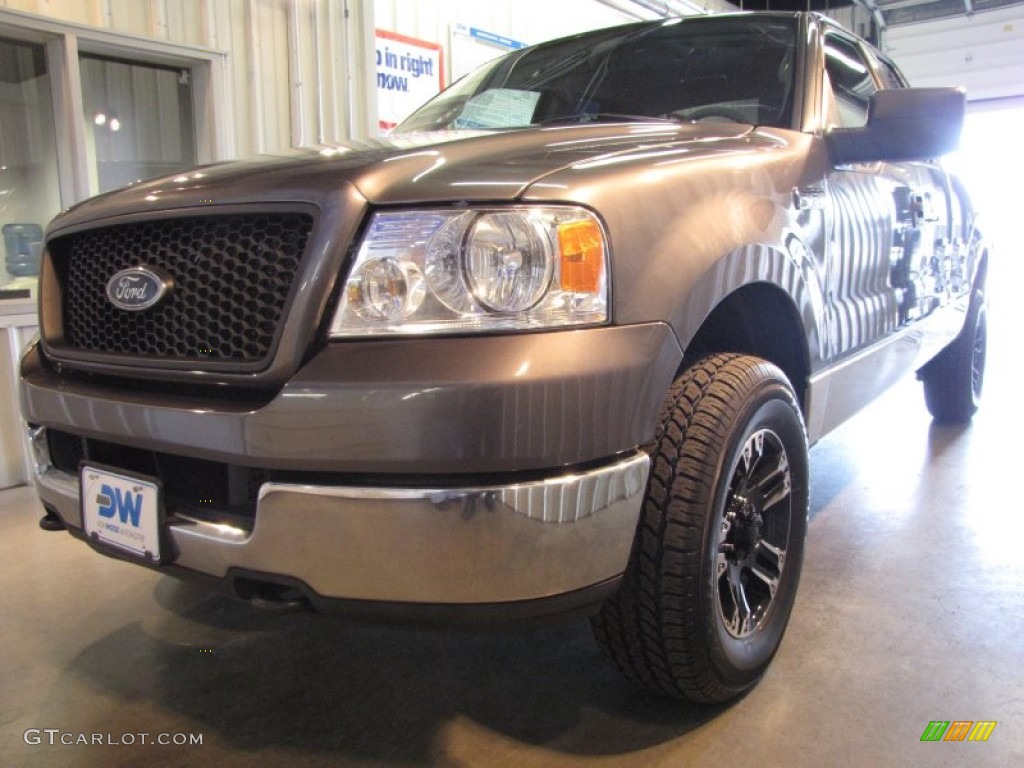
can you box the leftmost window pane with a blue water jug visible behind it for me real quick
[0,38,60,297]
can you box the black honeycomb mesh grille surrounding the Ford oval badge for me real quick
[50,213,312,364]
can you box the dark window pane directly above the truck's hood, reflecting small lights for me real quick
[81,54,196,193]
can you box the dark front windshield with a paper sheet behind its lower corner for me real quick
[394,15,797,133]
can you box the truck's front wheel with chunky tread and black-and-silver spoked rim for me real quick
[593,354,808,702]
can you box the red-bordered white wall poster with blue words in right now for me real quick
[377,30,444,130]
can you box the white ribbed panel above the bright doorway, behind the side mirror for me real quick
[886,5,1024,101]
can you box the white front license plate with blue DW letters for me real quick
[80,465,163,562]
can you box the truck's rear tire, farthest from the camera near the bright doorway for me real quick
[921,293,988,424]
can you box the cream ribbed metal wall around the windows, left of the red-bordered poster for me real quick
[0,0,385,160]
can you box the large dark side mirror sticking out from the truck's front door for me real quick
[825,88,967,165]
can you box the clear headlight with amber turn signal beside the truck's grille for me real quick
[331,206,608,337]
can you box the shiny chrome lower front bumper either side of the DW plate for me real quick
[30,428,649,605]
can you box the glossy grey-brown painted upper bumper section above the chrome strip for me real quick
[22,324,682,475]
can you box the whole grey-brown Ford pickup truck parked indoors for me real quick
[20,12,990,702]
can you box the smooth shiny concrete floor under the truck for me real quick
[0,302,1024,768]
